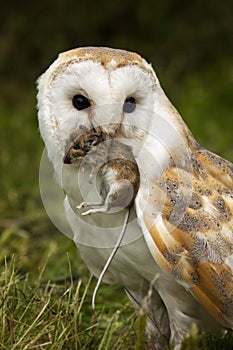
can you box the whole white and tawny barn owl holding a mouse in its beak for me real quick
[38,47,233,349]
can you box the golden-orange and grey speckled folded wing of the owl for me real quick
[139,148,233,329]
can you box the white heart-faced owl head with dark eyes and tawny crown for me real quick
[38,47,193,183]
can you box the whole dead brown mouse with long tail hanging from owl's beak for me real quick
[64,128,140,309]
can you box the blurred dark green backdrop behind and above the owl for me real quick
[0,0,233,278]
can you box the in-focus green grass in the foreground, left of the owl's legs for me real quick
[0,258,144,350]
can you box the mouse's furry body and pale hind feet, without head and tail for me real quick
[77,140,140,215]
